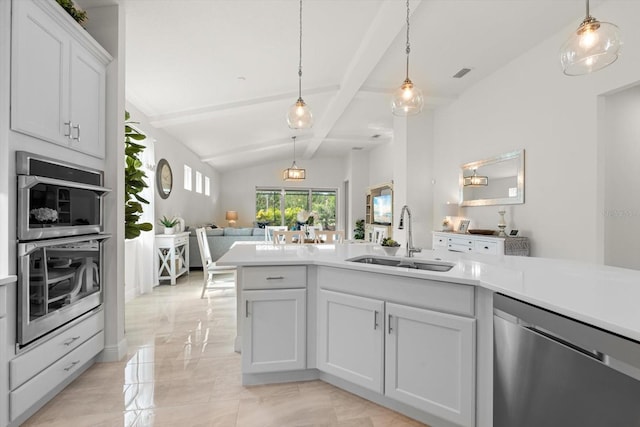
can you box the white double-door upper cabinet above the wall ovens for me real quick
[11,0,111,158]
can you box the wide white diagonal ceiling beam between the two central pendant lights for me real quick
[303,0,422,159]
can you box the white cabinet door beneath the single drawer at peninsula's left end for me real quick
[242,289,307,374]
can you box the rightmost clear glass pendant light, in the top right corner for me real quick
[560,0,622,76]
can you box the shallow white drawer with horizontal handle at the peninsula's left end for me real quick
[242,265,307,289]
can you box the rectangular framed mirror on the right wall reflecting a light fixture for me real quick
[460,150,524,206]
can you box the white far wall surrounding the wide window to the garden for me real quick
[221,158,350,230]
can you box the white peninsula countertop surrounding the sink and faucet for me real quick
[217,243,640,341]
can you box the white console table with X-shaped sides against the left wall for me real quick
[156,232,189,285]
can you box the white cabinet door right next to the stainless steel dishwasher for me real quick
[385,303,475,426]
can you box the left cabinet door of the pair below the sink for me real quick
[318,289,384,393]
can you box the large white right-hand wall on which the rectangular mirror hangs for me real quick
[434,0,640,261]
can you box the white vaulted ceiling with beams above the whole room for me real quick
[78,0,606,171]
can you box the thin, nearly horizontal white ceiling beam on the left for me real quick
[150,85,340,128]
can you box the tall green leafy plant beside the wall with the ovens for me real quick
[124,111,153,239]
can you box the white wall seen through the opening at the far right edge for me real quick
[603,85,640,270]
